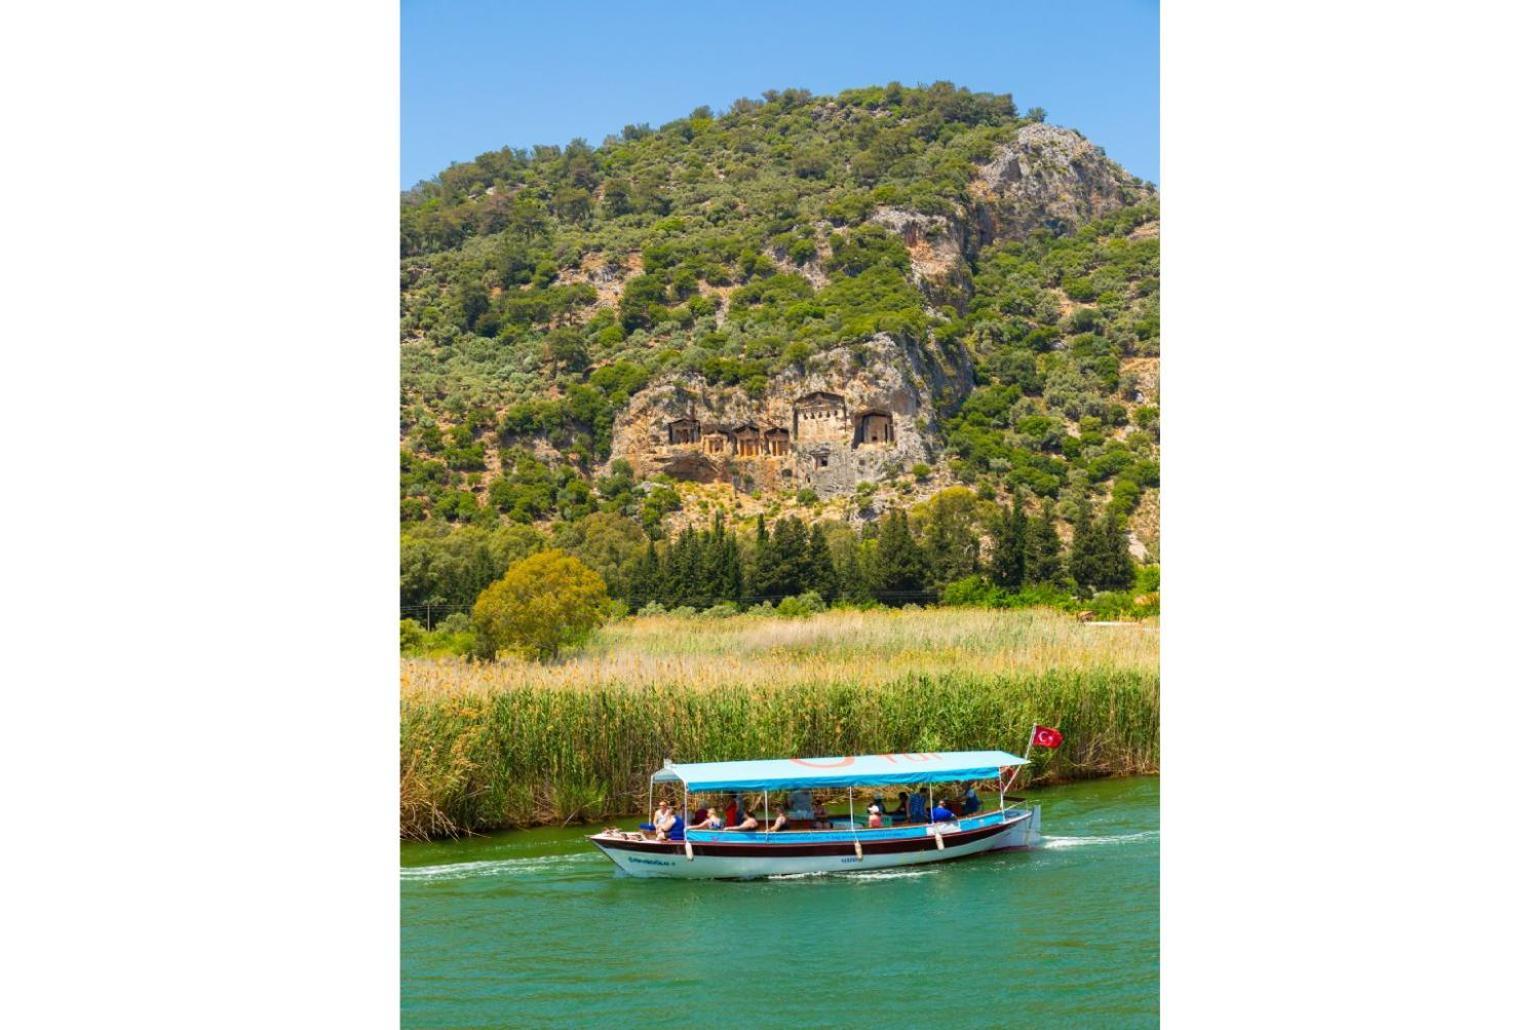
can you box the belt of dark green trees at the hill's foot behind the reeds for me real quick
[400,488,1160,653]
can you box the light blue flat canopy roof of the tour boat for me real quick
[653,751,1027,790]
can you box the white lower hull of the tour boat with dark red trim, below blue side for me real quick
[590,805,1043,879]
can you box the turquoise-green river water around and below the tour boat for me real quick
[400,776,1160,1027]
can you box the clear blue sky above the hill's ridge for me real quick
[400,0,1160,186]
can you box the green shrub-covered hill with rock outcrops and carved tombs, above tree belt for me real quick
[400,83,1160,618]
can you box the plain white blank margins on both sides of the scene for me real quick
[0,0,1540,1027]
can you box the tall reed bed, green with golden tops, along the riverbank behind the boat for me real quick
[400,610,1160,838]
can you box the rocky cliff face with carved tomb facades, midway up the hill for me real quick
[611,333,973,497]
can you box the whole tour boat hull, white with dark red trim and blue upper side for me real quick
[588,805,1041,879]
